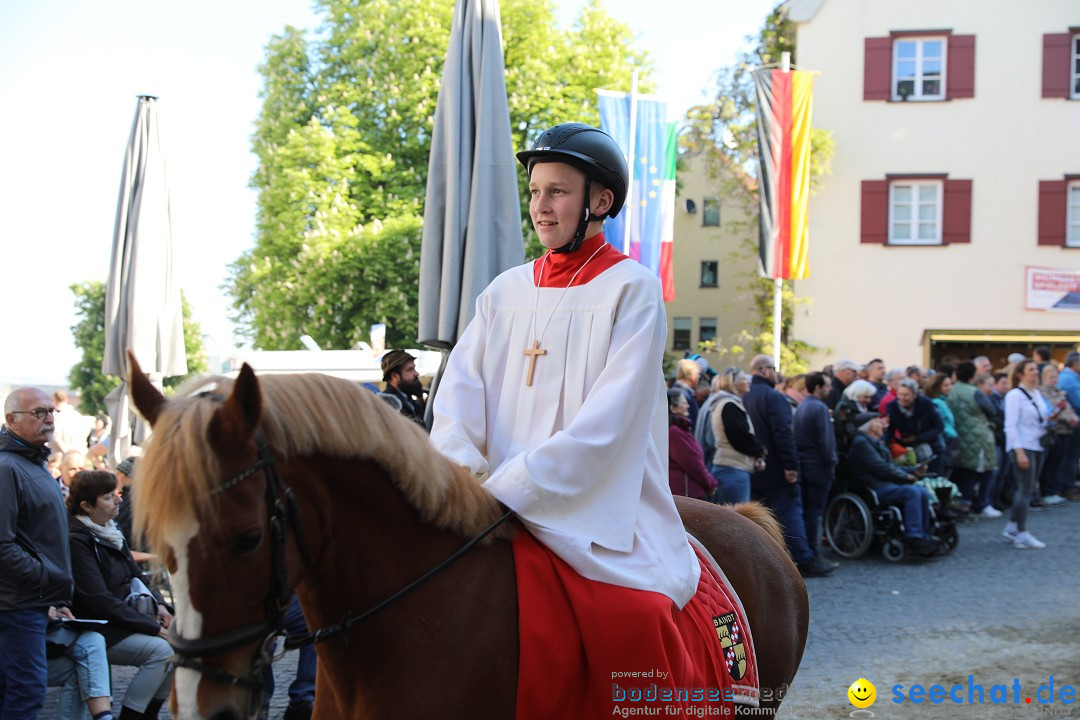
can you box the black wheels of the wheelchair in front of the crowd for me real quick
[822,480,960,562]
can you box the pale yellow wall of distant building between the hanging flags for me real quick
[667,155,757,369]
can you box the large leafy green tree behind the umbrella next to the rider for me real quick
[228,0,652,350]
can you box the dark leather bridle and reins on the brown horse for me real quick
[168,423,514,716]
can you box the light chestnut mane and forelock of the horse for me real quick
[135,373,509,552]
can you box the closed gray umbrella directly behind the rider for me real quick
[419,0,525,425]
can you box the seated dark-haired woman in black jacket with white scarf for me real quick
[68,470,173,720]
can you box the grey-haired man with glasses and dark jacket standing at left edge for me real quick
[0,388,72,720]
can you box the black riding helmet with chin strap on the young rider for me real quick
[517,122,630,253]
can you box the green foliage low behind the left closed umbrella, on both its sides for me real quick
[68,281,206,415]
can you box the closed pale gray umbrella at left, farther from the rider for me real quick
[102,95,188,462]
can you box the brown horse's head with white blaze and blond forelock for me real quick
[129,354,307,720]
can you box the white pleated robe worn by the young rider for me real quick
[431,255,700,608]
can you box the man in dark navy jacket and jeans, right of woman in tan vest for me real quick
[743,355,836,576]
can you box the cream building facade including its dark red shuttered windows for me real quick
[786,0,1080,367]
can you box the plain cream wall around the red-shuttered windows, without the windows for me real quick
[792,0,1080,366]
